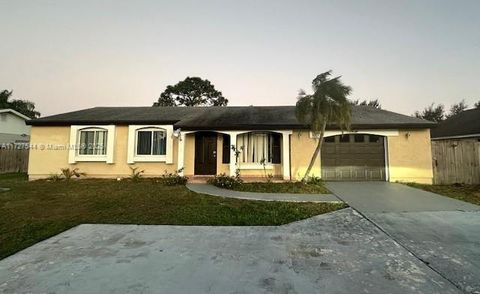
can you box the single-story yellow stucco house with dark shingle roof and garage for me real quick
[28,106,434,183]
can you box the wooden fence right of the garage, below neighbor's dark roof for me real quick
[432,139,480,184]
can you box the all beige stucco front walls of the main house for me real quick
[28,126,433,184]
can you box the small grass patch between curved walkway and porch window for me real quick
[233,182,330,194]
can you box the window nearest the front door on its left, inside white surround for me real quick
[135,129,167,155]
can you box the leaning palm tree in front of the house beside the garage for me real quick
[296,70,352,181]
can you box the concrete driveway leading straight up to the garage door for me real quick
[327,182,480,292]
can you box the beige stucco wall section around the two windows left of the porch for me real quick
[28,126,177,179]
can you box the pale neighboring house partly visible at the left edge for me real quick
[0,109,31,145]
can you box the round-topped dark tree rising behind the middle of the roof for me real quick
[153,77,228,106]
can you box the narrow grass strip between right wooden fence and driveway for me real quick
[408,183,480,205]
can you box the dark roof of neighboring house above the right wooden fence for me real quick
[431,108,480,138]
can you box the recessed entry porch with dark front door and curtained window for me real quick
[176,130,292,180]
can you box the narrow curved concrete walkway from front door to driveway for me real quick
[187,183,341,202]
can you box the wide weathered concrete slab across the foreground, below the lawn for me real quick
[0,208,459,293]
